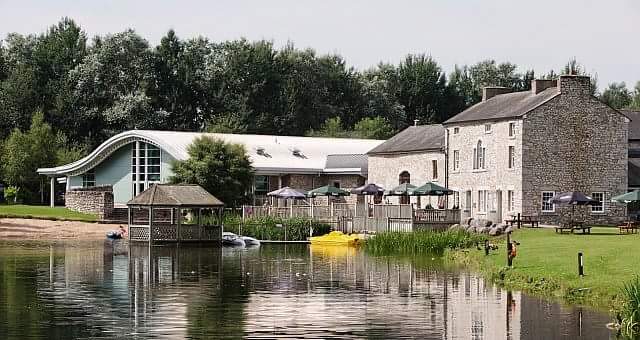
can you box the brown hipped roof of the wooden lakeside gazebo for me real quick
[127,184,224,208]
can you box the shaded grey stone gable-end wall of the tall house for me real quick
[522,76,629,224]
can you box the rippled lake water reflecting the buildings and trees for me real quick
[0,241,614,339]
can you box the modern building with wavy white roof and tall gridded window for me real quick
[38,130,383,206]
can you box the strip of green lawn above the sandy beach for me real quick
[0,204,97,222]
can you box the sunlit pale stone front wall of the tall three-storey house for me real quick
[447,118,523,222]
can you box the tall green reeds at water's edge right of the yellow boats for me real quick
[365,230,485,255]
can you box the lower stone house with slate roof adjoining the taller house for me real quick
[367,124,446,207]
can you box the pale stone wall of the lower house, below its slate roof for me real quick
[368,151,445,207]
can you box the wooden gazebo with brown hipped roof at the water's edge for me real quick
[127,184,224,244]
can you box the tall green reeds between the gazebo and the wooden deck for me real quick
[224,217,331,241]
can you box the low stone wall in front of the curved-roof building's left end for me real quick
[64,186,113,220]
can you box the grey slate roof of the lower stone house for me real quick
[367,124,445,155]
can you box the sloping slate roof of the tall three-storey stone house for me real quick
[444,87,560,124]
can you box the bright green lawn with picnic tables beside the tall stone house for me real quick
[450,227,640,310]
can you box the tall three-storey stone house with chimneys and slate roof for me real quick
[444,75,629,224]
